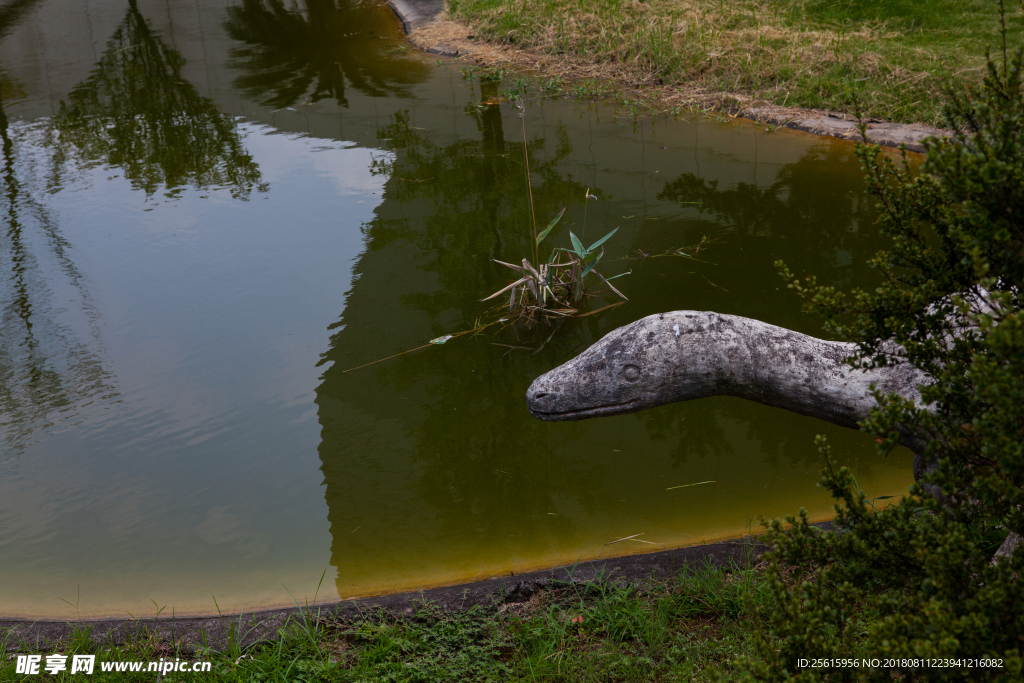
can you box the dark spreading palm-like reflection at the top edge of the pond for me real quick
[225,0,427,108]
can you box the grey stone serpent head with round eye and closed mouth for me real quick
[526,311,714,421]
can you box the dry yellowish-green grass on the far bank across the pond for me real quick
[447,0,1024,125]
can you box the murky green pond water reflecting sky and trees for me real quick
[0,0,911,617]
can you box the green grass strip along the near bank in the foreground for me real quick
[0,566,770,683]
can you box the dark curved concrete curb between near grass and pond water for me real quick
[0,522,815,652]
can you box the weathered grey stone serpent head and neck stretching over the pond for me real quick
[526,310,1020,555]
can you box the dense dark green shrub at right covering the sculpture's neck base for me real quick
[746,21,1024,681]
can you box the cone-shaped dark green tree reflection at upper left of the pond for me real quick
[50,0,265,199]
